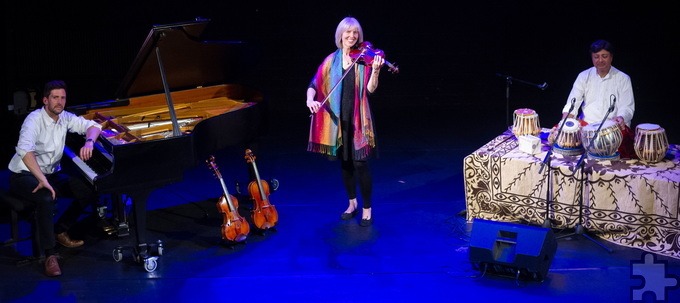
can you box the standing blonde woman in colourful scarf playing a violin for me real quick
[307,17,385,226]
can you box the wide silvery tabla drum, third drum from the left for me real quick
[581,120,623,160]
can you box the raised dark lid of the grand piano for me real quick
[116,18,245,99]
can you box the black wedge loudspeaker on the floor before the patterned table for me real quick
[468,219,557,281]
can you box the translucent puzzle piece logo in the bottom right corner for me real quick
[630,253,680,302]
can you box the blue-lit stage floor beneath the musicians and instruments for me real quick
[0,103,680,303]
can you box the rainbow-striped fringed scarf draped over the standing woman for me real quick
[307,49,375,160]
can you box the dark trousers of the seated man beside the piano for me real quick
[10,172,99,255]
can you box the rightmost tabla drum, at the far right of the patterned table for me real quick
[633,123,668,163]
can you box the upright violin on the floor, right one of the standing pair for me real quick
[245,149,279,230]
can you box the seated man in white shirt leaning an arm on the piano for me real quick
[9,80,101,277]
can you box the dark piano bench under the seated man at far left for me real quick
[0,188,44,263]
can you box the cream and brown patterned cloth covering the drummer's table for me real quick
[463,130,680,259]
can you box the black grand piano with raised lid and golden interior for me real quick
[65,19,266,271]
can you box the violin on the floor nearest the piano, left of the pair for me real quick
[205,156,250,242]
